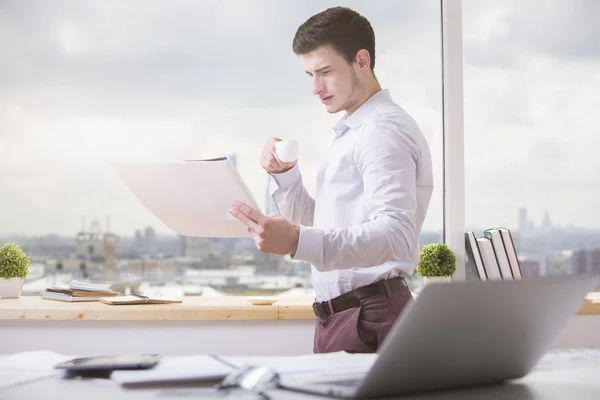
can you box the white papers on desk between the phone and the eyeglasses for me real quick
[110,355,235,386]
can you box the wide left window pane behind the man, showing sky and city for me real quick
[0,0,443,295]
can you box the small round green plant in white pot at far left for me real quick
[0,242,29,298]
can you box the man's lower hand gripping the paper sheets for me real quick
[229,201,300,254]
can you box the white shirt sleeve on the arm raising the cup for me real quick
[269,163,315,226]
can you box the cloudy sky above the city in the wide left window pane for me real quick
[0,0,442,234]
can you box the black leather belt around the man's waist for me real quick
[313,277,408,318]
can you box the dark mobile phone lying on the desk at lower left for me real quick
[54,354,160,372]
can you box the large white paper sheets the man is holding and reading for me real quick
[112,158,260,237]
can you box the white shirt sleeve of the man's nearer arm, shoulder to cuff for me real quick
[294,121,420,271]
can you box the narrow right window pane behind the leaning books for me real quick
[463,0,600,284]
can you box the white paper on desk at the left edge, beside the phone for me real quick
[0,351,73,389]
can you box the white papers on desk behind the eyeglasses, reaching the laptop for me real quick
[222,351,377,376]
